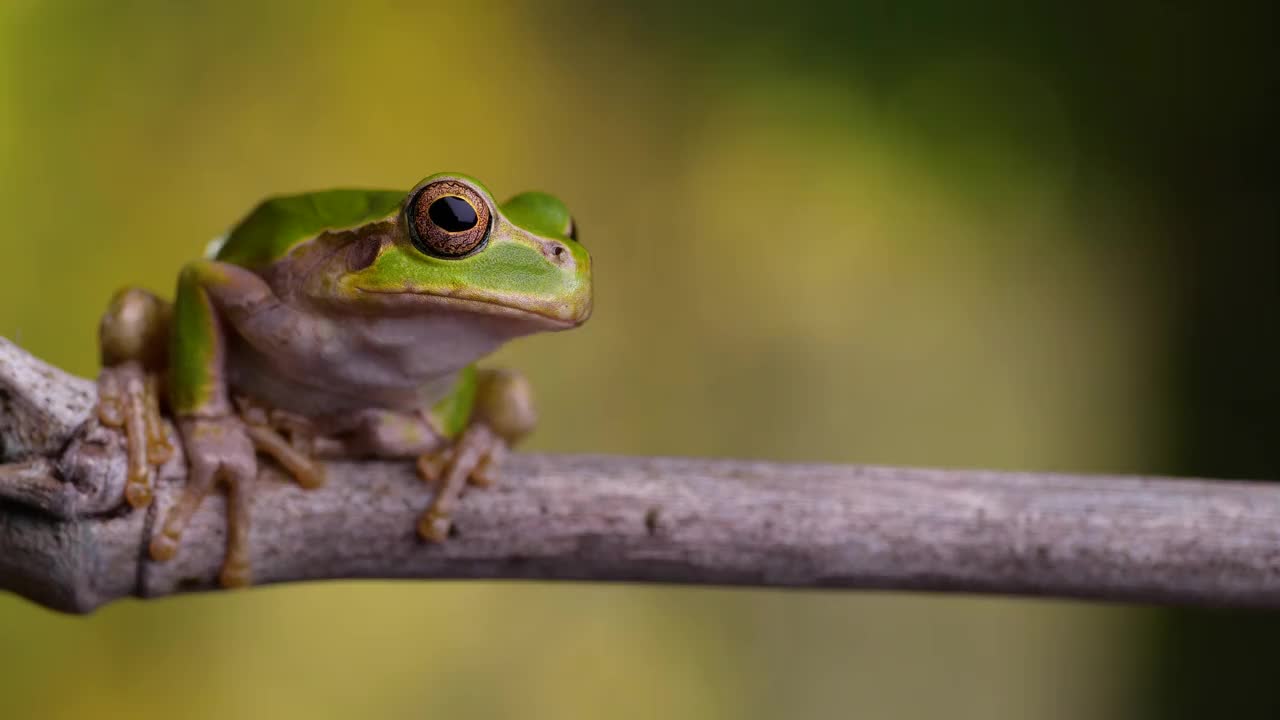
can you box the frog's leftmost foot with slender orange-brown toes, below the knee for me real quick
[97,361,173,509]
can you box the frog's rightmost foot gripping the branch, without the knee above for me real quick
[417,423,508,542]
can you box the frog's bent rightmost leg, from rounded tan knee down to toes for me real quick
[417,369,538,542]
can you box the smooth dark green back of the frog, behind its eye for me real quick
[209,190,406,269]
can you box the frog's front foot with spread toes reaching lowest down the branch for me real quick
[150,415,257,588]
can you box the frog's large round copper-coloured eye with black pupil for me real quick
[406,181,492,258]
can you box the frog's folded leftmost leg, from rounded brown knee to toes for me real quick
[97,287,173,509]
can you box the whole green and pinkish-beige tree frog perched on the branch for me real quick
[97,173,591,587]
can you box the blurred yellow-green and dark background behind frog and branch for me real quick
[0,0,1280,720]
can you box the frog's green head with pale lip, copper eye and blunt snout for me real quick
[312,173,591,333]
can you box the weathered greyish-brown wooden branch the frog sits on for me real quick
[0,338,1280,612]
